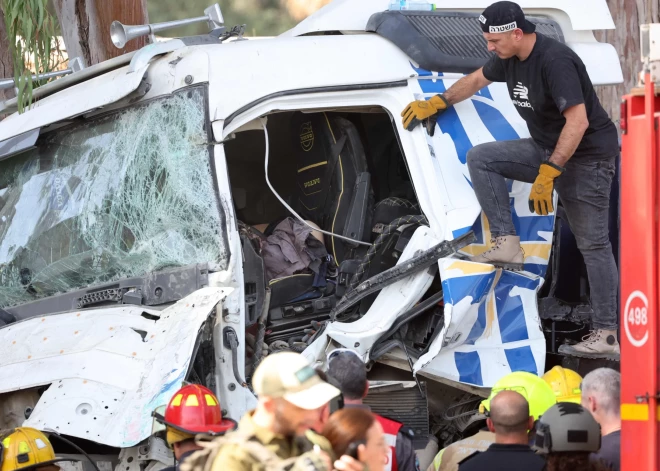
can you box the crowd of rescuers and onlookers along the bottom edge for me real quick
[0,349,621,471]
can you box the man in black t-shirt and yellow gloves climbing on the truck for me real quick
[402,2,619,360]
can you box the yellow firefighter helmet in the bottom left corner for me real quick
[0,427,70,471]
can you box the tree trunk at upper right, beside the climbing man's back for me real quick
[595,0,660,126]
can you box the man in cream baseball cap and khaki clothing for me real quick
[211,352,364,471]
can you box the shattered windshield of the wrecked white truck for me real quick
[0,87,227,307]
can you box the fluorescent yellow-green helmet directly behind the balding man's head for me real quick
[479,371,557,420]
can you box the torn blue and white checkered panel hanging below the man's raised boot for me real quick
[423,258,546,387]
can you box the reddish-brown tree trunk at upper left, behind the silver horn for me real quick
[53,0,149,66]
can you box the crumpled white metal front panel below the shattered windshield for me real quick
[0,288,232,448]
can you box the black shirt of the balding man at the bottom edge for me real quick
[458,443,545,471]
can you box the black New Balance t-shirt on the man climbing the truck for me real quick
[483,33,619,160]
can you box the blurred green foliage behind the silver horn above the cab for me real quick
[147,0,296,36]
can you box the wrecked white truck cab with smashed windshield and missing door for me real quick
[0,0,622,471]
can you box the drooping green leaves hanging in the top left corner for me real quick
[2,0,56,113]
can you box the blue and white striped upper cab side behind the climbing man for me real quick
[412,66,555,276]
